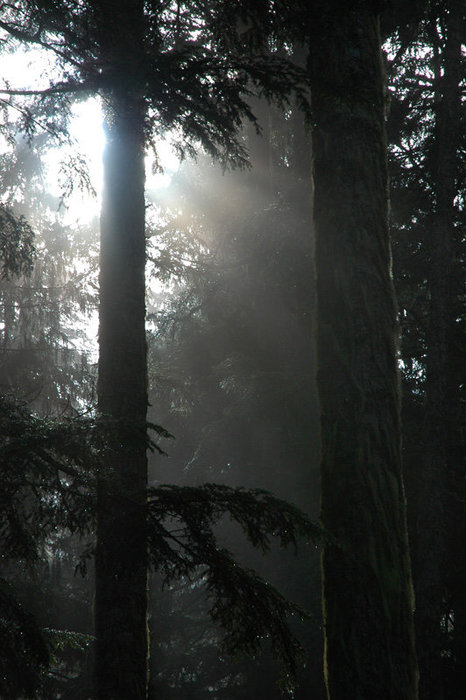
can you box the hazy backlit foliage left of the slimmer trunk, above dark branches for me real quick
[0,110,97,413]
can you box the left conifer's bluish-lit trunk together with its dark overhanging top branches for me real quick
[0,0,314,700]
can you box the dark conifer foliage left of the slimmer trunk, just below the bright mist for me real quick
[0,397,97,563]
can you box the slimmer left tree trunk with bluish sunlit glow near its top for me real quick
[95,0,148,700]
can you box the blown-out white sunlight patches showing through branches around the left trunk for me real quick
[0,49,179,362]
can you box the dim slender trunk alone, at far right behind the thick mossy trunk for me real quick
[415,2,464,700]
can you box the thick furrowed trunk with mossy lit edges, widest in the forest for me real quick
[310,0,417,700]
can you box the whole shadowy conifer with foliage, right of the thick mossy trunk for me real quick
[388,0,466,698]
